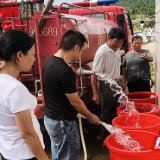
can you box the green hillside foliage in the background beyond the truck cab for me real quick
[115,0,155,16]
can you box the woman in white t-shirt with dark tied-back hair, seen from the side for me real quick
[0,30,49,160]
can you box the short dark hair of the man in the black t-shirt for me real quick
[59,30,87,51]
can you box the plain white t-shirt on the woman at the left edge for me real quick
[0,74,44,160]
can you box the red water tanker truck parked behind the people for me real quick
[0,0,133,119]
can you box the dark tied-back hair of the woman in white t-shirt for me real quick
[0,29,35,61]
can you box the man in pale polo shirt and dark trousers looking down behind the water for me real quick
[91,27,125,139]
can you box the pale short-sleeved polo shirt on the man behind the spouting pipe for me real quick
[92,43,121,80]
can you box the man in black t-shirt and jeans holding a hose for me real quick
[42,30,99,160]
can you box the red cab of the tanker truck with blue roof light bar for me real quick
[69,0,133,52]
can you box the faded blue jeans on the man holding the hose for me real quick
[44,116,80,160]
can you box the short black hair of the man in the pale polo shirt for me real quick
[108,27,125,40]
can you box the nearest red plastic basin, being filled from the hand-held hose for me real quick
[104,130,160,160]
